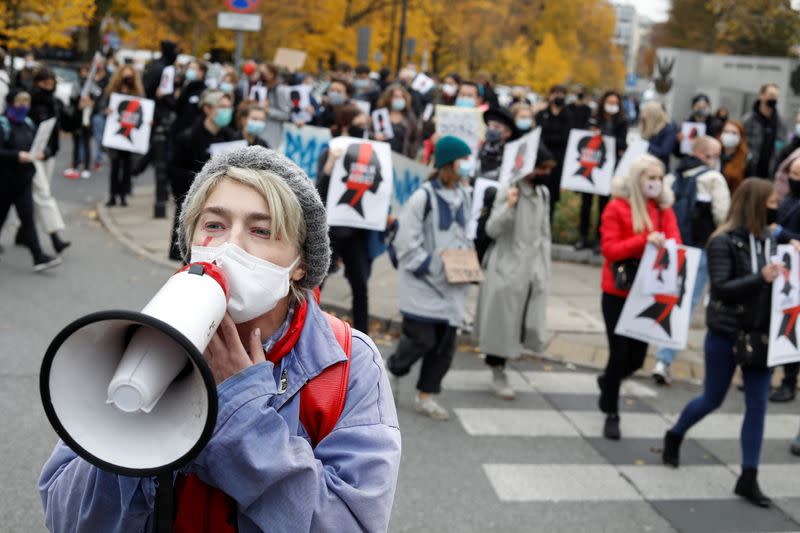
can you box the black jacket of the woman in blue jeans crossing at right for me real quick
[706,228,776,340]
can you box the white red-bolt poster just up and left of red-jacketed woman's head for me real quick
[561,130,617,196]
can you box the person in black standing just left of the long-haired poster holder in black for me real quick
[536,85,575,221]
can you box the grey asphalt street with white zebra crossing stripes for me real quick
[0,147,800,532]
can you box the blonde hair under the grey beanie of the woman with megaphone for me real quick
[182,167,307,301]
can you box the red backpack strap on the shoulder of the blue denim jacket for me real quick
[300,313,353,448]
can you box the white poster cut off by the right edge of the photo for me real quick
[767,244,800,366]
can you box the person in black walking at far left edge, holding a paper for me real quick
[0,89,61,272]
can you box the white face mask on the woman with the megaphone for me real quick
[191,242,300,324]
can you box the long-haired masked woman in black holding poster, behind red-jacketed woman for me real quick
[575,91,628,253]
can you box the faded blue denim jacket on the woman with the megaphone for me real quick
[39,302,400,533]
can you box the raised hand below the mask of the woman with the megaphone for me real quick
[203,313,267,385]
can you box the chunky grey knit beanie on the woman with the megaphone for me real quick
[178,146,331,290]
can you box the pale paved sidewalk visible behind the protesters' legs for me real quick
[97,185,705,383]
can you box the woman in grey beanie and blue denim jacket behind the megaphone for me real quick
[39,146,400,532]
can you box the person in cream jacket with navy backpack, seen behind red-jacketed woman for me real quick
[652,135,731,385]
